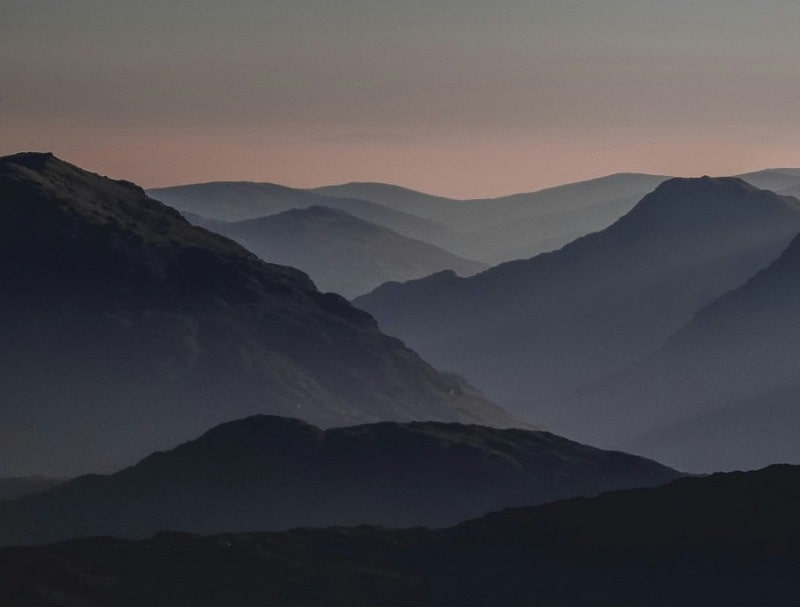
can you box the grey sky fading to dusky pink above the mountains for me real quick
[0,0,800,197]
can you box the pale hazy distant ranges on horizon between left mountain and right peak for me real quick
[149,174,666,263]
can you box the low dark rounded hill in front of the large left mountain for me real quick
[0,416,680,545]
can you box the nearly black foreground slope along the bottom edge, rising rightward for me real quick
[0,466,800,607]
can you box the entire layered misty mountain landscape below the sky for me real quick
[0,152,800,607]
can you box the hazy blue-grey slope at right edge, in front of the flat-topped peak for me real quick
[558,230,800,470]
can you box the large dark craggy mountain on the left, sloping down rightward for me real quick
[0,153,517,476]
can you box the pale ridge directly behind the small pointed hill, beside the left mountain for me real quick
[148,181,456,248]
